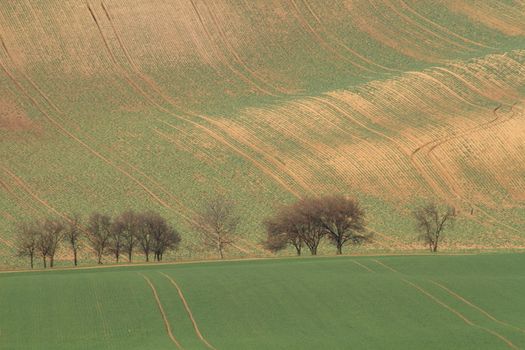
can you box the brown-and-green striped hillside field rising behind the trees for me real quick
[0,0,525,264]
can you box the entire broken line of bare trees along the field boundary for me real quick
[16,194,456,268]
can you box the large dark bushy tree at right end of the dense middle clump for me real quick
[313,195,368,255]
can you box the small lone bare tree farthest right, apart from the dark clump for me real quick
[414,203,456,252]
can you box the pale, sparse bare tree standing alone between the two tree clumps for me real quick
[194,195,239,259]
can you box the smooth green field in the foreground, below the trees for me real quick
[0,254,525,349]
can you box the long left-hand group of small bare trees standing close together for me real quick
[17,211,181,268]
